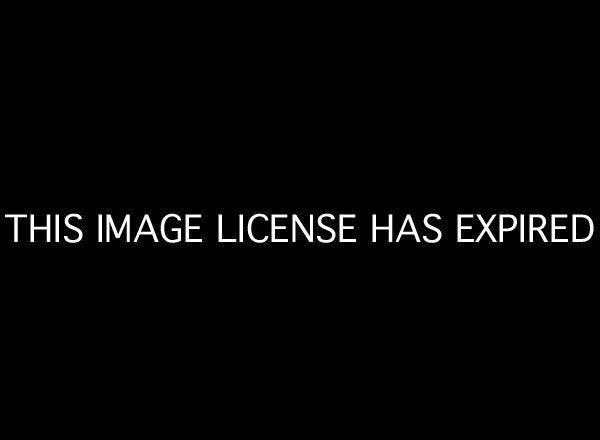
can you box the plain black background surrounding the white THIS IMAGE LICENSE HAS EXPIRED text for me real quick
[1,5,598,433]
